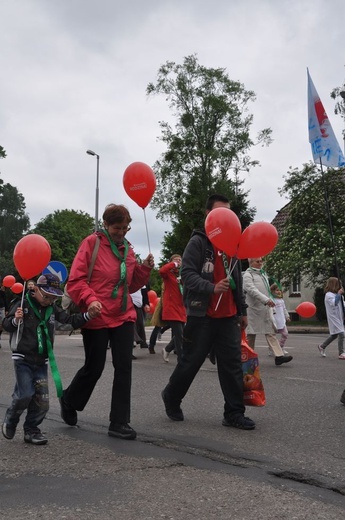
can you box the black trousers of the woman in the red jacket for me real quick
[64,322,134,423]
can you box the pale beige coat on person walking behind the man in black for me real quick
[243,267,275,334]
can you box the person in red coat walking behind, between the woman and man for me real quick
[159,254,187,363]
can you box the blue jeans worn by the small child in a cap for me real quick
[6,359,49,432]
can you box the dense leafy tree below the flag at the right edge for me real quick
[266,163,345,286]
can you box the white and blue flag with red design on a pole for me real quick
[307,69,345,168]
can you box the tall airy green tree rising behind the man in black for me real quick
[146,55,271,254]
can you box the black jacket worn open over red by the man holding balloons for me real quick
[181,231,247,316]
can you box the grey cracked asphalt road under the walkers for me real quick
[0,328,345,520]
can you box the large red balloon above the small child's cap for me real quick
[13,234,51,280]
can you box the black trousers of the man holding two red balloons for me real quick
[164,316,245,418]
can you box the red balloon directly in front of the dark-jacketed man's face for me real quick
[205,208,242,256]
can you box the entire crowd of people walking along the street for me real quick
[0,194,345,445]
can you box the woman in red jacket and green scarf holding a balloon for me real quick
[60,204,154,439]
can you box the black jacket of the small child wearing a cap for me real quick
[3,298,89,365]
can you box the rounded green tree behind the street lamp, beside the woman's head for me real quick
[33,209,94,269]
